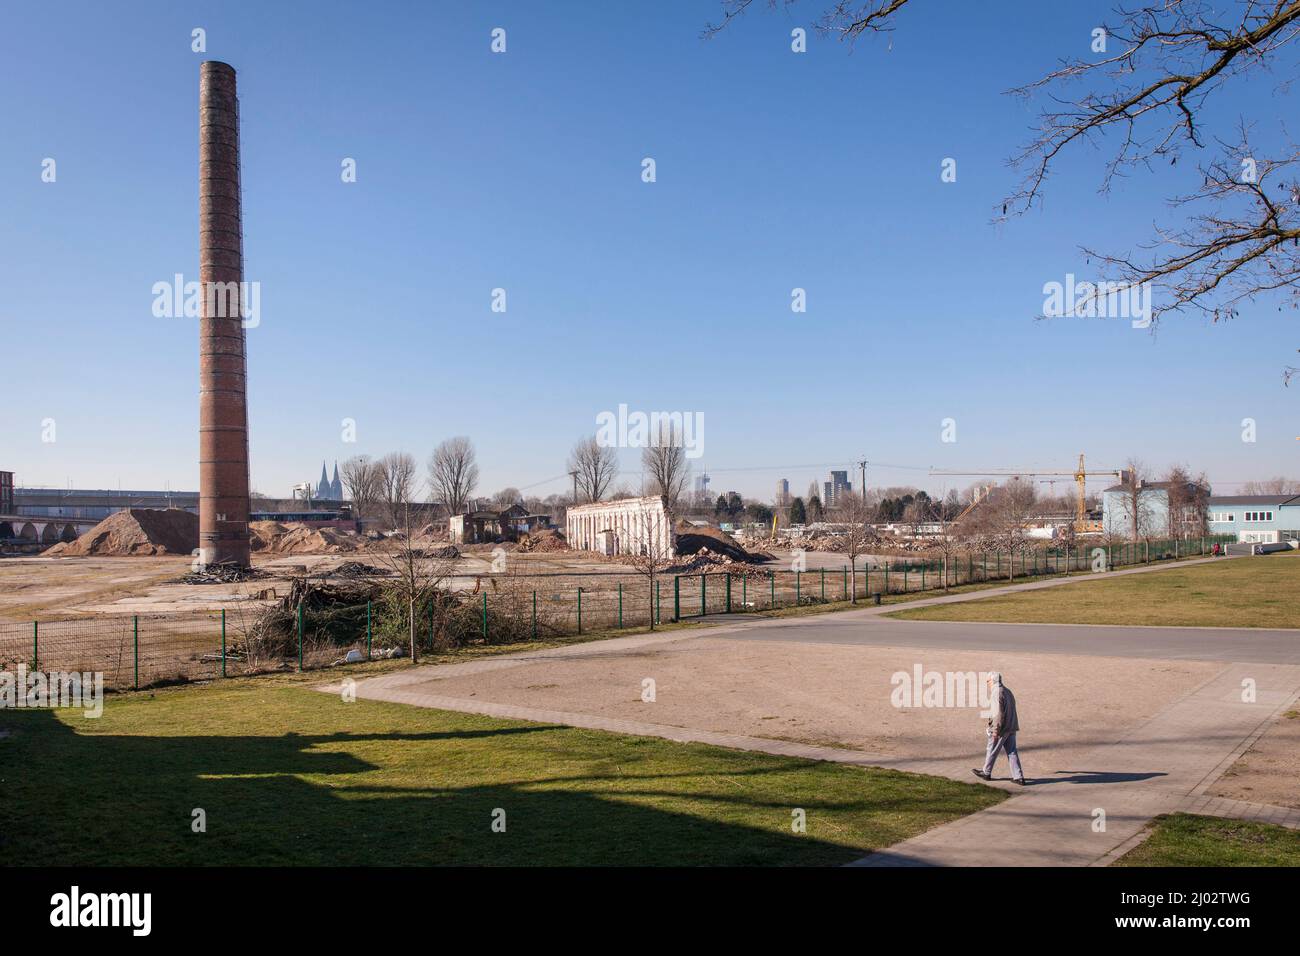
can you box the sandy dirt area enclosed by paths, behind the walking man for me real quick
[392,637,1223,777]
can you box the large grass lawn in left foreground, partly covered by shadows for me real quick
[0,678,1004,865]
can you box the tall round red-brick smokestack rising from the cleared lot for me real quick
[199,60,248,567]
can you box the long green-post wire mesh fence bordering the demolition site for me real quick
[0,536,1234,689]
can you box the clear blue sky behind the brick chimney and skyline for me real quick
[0,0,1300,498]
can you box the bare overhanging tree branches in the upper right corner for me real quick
[705,0,1300,382]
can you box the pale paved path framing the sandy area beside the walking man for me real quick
[320,556,1300,866]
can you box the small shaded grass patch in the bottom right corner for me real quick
[1114,813,1300,866]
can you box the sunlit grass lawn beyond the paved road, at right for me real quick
[889,551,1300,627]
